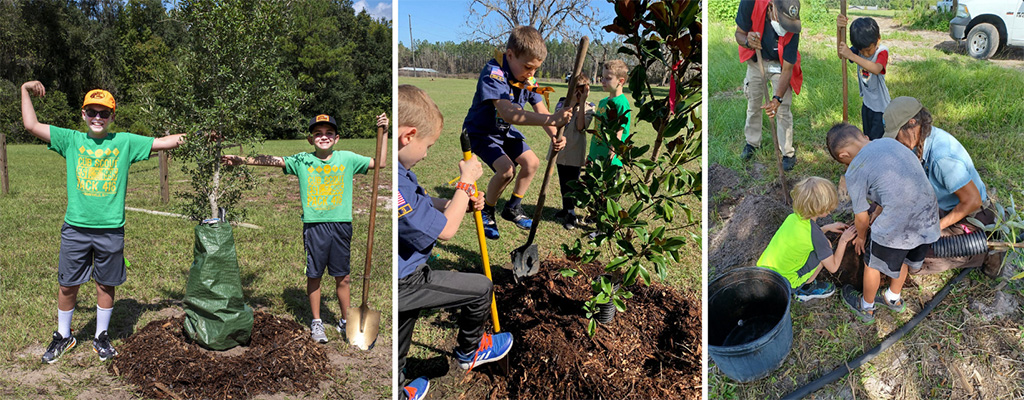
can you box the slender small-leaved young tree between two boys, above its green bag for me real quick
[147,0,302,219]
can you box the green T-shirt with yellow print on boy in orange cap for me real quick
[47,125,154,229]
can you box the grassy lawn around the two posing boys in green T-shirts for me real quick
[0,139,392,398]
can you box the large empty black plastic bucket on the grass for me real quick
[708,267,793,382]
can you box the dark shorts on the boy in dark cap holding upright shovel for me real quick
[302,222,352,278]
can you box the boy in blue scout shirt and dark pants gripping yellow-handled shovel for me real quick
[395,85,512,399]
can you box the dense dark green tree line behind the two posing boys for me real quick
[0,0,391,142]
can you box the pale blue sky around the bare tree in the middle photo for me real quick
[395,0,614,46]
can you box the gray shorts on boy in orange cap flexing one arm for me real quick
[57,223,128,287]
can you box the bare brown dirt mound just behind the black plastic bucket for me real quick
[708,194,793,276]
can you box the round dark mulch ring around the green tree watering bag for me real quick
[109,311,330,399]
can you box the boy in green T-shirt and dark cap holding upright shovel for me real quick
[222,114,388,343]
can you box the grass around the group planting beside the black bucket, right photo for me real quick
[707,10,1024,399]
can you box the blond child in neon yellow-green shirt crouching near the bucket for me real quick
[758,176,857,302]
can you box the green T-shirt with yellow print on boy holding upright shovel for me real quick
[285,151,372,223]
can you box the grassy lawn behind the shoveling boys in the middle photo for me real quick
[399,77,701,392]
